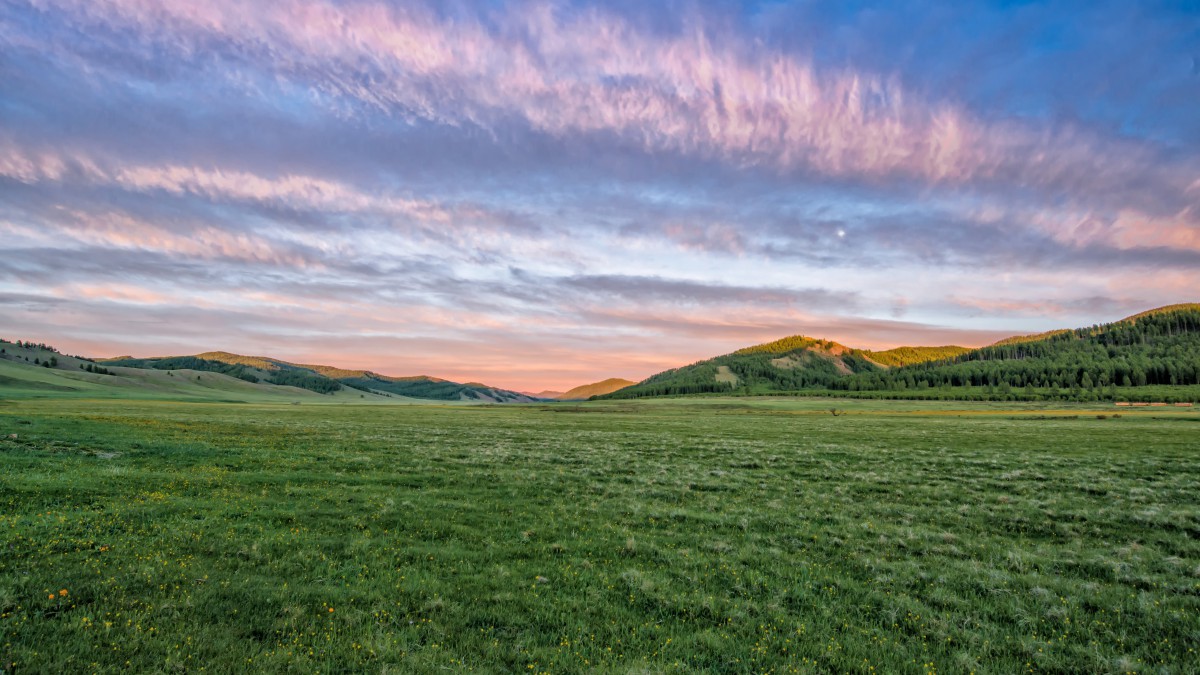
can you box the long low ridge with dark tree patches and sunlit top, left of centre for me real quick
[104,352,535,404]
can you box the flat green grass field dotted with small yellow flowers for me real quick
[0,399,1200,674]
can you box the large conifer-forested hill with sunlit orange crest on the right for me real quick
[602,304,1200,399]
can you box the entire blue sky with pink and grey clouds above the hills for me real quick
[0,0,1200,392]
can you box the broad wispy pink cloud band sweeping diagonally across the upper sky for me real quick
[25,0,1195,201]
